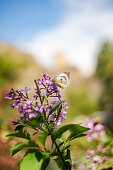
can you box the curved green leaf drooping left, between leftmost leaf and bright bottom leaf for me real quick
[11,140,39,156]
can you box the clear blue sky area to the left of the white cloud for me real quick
[0,0,64,41]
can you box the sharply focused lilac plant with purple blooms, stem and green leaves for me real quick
[5,73,89,170]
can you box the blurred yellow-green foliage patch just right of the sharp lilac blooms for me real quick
[67,87,97,119]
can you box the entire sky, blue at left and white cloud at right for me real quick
[0,0,113,75]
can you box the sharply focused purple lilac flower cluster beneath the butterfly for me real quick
[5,73,68,126]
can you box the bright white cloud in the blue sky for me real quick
[21,0,113,75]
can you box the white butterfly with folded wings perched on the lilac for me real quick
[52,72,70,89]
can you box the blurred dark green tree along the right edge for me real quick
[96,42,113,112]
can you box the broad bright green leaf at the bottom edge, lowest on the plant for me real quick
[20,149,49,170]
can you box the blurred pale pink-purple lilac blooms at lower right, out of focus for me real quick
[78,119,109,170]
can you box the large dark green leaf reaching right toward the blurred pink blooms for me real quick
[51,124,89,142]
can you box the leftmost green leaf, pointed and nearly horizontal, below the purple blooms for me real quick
[6,129,31,140]
